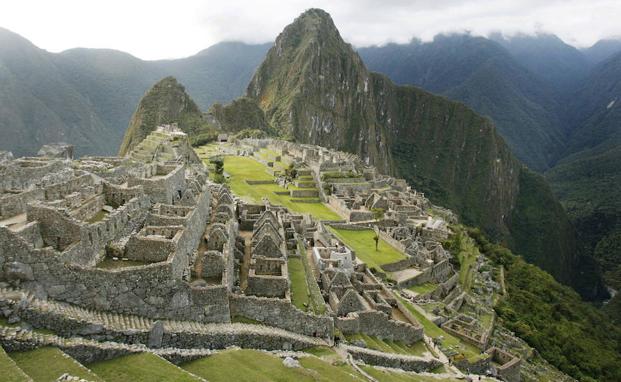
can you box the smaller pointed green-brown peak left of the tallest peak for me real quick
[119,77,213,155]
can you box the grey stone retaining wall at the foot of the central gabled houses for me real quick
[229,294,334,342]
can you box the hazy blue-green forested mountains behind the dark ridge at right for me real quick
[359,29,621,304]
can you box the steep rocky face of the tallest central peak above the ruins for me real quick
[247,9,392,172]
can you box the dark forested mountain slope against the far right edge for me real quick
[546,53,621,304]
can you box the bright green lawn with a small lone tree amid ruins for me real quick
[330,227,406,273]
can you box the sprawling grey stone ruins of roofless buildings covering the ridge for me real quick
[0,132,524,375]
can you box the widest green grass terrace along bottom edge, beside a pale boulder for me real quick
[181,349,362,382]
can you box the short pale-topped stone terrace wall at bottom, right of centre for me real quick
[342,345,442,372]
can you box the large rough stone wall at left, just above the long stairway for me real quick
[0,189,230,322]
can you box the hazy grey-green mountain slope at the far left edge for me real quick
[0,29,114,155]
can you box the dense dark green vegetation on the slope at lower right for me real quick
[468,229,621,381]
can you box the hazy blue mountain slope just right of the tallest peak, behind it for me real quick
[358,34,564,170]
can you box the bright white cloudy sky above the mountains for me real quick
[0,0,621,59]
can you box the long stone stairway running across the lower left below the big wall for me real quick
[0,288,327,350]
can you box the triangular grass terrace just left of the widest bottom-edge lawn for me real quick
[89,353,199,382]
